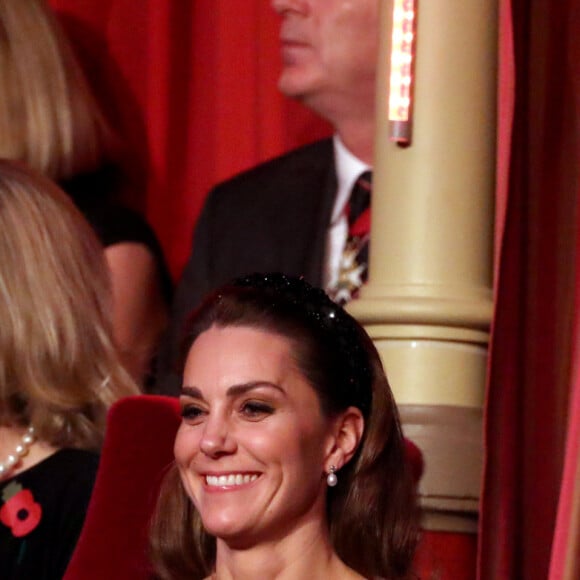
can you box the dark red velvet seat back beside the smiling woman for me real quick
[65,395,180,580]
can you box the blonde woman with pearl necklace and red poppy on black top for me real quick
[0,161,138,579]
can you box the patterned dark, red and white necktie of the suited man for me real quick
[331,171,372,304]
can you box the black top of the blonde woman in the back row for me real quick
[59,166,173,305]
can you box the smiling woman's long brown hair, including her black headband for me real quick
[151,274,418,579]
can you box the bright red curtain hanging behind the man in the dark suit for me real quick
[49,0,330,277]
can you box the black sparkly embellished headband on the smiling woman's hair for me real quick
[232,273,373,416]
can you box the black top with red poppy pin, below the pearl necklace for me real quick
[0,449,99,580]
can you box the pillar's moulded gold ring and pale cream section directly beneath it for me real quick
[347,292,492,408]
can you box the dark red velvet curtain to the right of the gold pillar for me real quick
[479,0,580,580]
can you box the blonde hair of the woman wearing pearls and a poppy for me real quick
[0,160,138,449]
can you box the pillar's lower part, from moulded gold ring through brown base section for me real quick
[348,292,492,534]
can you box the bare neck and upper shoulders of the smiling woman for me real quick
[210,525,362,580]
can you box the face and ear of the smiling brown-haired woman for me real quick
[175,327,363,544]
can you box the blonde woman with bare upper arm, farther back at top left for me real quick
[0,0,171,388]
